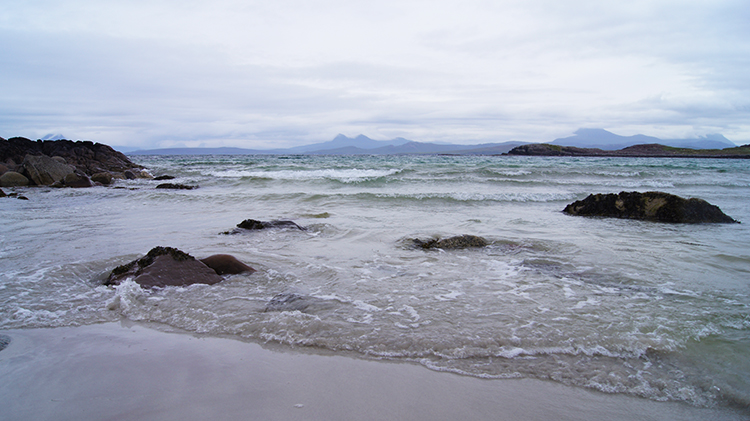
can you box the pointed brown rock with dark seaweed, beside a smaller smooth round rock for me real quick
[105,247,222,288]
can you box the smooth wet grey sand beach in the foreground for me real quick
[0,320,742,420]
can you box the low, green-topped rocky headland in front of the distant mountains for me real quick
[503,143,750,159]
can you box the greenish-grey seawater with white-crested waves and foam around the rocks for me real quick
[0,156,750,408]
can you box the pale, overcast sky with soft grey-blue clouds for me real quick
[0,0,750,149]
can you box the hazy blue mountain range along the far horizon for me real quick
[123,129,737,155]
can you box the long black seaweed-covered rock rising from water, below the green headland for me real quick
[563,192,738,223]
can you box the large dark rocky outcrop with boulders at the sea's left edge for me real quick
[0,137,151,187]
